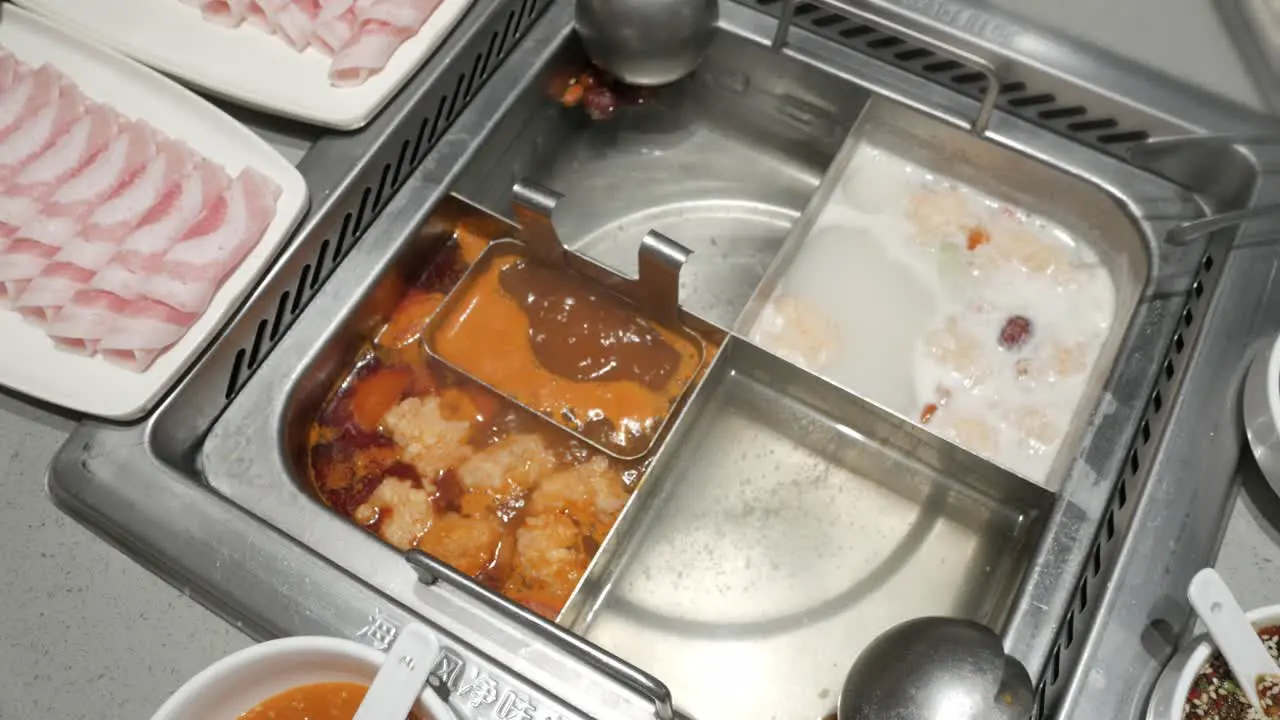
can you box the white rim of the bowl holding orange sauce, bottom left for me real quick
[151,637,433,720]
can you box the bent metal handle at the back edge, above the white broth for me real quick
[773,0,1001,137]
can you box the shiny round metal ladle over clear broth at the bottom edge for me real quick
[837,618,1034,720]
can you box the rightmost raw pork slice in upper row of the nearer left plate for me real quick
[142,168,280,314]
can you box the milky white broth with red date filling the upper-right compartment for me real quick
[750,145,1116,484]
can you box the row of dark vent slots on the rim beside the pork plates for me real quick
[224,0,549,401]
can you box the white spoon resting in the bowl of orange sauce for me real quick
[352,624,457,720]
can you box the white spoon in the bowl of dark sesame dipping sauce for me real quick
[1187,568,1280,712]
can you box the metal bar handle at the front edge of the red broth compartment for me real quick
[404,550,676,720]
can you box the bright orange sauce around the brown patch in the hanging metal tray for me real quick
[430,248,701,456]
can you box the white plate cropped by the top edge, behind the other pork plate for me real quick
[17,0,471,129]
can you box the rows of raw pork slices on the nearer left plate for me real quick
[0,49,285,372]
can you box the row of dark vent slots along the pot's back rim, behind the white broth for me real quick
[735,0,1151,155]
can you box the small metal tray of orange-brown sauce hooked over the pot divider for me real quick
[422,183,708,460]
